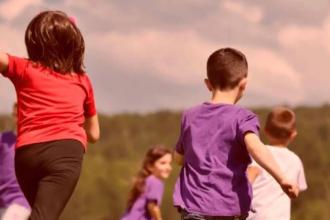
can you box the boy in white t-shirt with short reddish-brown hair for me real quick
[248,107,307,220]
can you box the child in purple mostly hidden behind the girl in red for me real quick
[0,104,31,220]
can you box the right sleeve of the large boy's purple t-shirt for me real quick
[237,110,260,143]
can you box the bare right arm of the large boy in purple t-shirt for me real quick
[244,132,299,198]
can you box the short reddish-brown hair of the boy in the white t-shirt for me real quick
[265,107,296,140]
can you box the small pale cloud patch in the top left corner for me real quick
[0,0,42,20]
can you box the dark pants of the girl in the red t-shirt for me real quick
[15,140,84,220]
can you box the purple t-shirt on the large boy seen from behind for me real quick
[173,102,259,216]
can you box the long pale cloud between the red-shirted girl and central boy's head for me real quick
[89,30,219,84]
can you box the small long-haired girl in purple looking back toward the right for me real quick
[121,147,172,220]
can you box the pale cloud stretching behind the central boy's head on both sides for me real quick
[89,27,304,109]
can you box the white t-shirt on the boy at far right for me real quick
[248,146,307,220]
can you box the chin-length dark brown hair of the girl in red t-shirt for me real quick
[25,11,85,74]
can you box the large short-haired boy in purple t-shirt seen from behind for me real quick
[173,48,298,220]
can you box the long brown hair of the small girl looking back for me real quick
[127,145,171,210]
